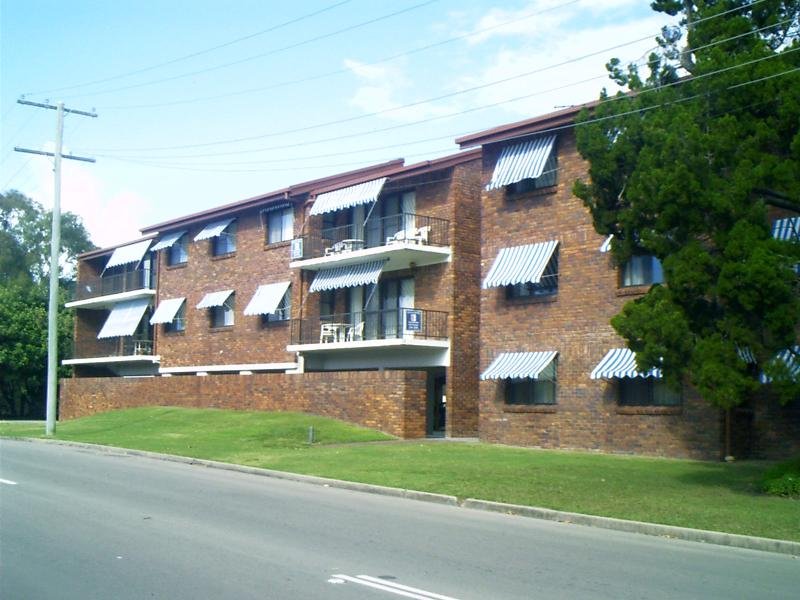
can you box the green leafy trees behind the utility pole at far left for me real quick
[0,191,93,418]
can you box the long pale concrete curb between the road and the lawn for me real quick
[7,438,800,556]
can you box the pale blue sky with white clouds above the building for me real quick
[0,0,668,247]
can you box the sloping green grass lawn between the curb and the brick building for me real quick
[0,408,800,541]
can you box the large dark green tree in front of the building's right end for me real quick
[574,0,800,408]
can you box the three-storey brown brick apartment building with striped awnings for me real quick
[61,103,800,458]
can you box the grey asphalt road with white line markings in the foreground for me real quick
[0,440,800,600]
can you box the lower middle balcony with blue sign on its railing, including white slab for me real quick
[286,308,450,370]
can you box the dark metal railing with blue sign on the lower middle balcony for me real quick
[291,308,447,345]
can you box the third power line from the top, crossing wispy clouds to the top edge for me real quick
[98,0,581,110]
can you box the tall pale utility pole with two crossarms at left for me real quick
[14,98,97,435]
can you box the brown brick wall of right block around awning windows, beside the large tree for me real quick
[480,125,722,458]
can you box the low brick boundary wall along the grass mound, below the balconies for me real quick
[59,371,427,438]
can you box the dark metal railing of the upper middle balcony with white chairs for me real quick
[292,213,450,260]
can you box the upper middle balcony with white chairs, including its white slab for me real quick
[289,213,450,271]
